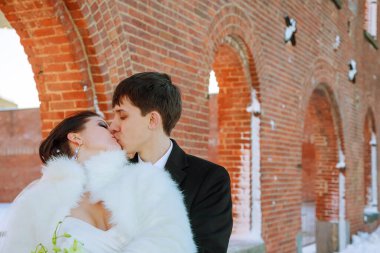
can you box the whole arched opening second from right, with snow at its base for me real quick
[301,84,346,252]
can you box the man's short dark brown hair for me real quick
[112,72,182,136]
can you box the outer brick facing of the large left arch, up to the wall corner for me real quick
[65,0,133,117]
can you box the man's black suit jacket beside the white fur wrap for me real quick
[133,140,232,253]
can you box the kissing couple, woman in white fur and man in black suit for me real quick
[0,72,232,253]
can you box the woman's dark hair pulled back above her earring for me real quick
[39,111,99,163]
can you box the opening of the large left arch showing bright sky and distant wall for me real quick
[0,10,41,202]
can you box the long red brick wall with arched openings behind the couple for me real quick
[0,0,380,253]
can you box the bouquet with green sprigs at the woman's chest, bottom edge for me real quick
[31,221,84,253]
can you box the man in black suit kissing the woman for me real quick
[110,72,232,253]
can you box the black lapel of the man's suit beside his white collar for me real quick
[165,139,188,185]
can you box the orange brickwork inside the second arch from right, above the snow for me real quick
[301,83,344,247]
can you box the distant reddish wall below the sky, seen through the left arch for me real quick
[0,108,42,203]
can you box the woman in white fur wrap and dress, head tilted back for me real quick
[0,111,196,253]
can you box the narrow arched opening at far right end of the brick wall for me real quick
[362,108,379,226]
